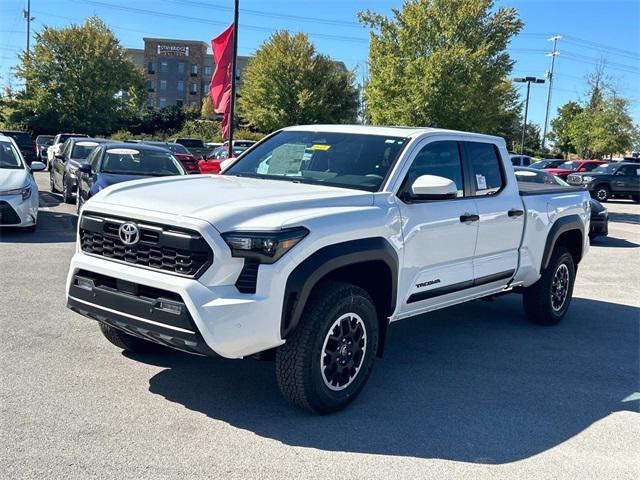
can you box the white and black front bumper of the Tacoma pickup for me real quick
[67,252,284,358]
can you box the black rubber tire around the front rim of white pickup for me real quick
[276,282,378,414]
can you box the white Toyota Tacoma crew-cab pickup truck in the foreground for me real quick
[67,125,590,413]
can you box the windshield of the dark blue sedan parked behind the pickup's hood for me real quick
[102,148,184,177]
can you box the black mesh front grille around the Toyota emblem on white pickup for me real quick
[80,212,213,277]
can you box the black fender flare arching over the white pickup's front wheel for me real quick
[280,237,399,342]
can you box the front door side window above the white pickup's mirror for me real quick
[404,141,464,197]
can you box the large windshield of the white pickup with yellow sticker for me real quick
[225,131,407,192]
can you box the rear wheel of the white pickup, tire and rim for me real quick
[522,247,576,325]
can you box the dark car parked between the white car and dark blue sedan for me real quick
[49,137,108,203]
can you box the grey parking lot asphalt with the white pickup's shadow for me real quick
[0,173,640,480]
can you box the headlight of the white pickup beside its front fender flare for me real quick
[222,227,309,263]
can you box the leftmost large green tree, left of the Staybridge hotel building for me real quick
[12,17,146,134]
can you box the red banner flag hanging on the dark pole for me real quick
[209,23,235,138]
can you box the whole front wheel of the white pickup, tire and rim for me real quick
[276,282,378,414]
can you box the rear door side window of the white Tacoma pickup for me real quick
[465,142,505,196]
